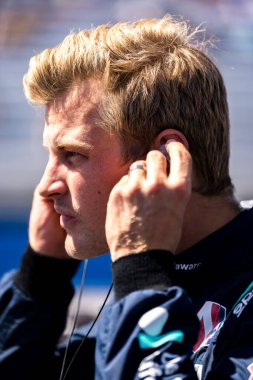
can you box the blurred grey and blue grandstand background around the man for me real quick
[0,0,253,314]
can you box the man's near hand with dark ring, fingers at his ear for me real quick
[105,141,191,261]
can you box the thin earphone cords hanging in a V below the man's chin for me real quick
[60,260,113,380]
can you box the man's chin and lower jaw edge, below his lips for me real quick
[65,235,108,260]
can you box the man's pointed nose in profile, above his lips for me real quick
[38,161,67,199]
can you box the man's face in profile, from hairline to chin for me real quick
[39,80,130,259]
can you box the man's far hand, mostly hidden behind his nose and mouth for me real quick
[29,187,69,259]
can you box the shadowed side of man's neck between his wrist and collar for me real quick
[177,193,241,253]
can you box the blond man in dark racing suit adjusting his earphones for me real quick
[0,17,253,379]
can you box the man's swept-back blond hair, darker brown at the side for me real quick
[24,16,233,195]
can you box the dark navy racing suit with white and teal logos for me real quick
[0,209,253,380]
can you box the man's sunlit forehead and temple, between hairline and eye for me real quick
[43,79,126,162]
